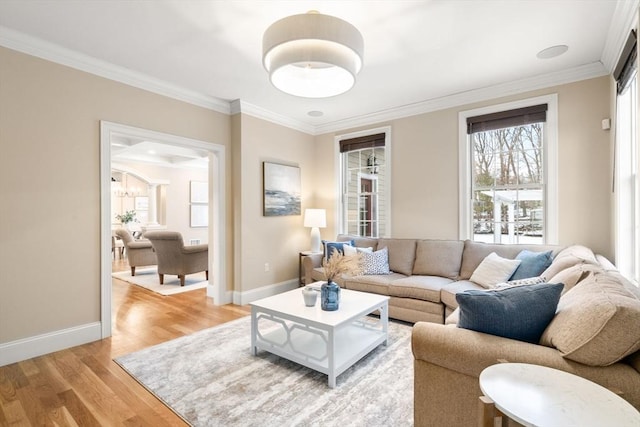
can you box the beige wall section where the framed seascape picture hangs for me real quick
[233,115,315,292]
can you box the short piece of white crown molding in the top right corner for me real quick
[601,0,639,73]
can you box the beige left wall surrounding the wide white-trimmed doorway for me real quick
[0,48,231,343]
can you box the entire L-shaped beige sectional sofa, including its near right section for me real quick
[304,236,640,426]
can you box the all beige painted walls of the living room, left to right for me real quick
[0,43,612,354]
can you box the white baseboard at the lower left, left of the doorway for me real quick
[0,322,102,366]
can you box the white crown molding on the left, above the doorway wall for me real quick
[0,26,230,114]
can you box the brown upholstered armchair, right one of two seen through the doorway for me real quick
[144,231,209,286]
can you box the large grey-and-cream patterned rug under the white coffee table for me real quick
[114,316,413,427]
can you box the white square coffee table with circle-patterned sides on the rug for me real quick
[250,283,389,388]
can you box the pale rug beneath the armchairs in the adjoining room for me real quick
[111,267,207,295]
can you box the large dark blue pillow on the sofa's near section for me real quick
[456,283,564,343]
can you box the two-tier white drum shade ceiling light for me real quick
[262,11,364,98]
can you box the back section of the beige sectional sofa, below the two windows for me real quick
[303,235,562,323]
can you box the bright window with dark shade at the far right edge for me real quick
[613,32,640,283]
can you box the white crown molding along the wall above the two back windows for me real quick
[314,62,609,135]
